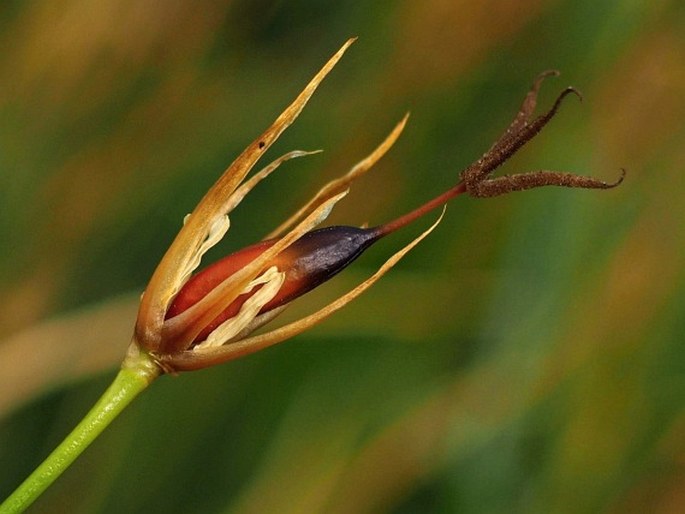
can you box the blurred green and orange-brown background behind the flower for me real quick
[0,0,685,514]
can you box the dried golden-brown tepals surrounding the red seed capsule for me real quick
[130,39,430,371]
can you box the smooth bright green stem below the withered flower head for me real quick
[0,345,162,514]
